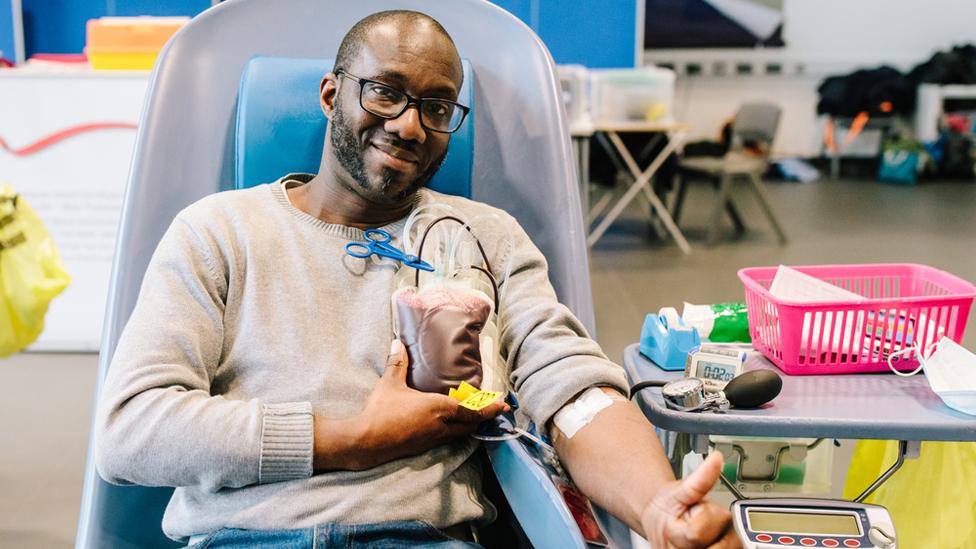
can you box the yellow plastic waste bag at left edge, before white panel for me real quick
[0,184,71,357]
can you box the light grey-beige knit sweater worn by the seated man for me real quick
[95,175,626,541]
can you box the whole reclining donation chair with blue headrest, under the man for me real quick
[76,0,629,549]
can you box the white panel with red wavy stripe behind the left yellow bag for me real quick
[0,66,149,352]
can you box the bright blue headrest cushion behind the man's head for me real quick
[234,57,475,197]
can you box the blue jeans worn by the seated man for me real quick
[191,520,481,549]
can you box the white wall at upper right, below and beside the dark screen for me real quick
[645,0,976,157]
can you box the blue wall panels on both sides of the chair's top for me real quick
[22,0,644,67]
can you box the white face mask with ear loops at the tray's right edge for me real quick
[888,337,976,416]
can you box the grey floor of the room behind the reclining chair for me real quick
[0,181,976,548]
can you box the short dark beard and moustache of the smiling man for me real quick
[330,104,447,202]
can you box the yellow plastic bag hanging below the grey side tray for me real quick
[844,440,976,549]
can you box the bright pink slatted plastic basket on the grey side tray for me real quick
[738,263,976,375]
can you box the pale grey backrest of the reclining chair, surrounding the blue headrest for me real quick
[76,0,594,549]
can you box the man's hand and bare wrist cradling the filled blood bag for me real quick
[314,340,509,471]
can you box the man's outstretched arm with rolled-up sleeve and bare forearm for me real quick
[496,218,739,549]
